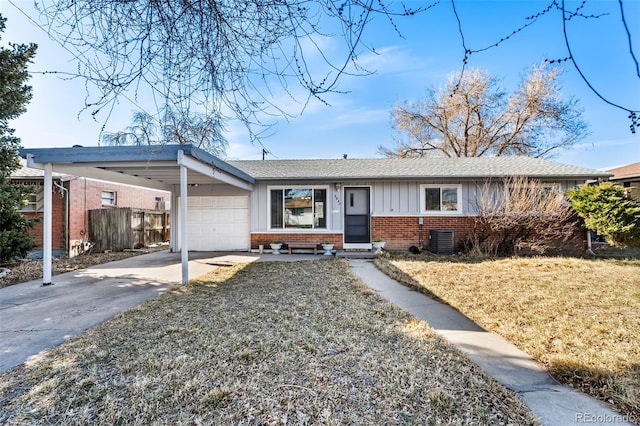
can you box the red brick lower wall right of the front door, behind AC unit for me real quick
[371,216,474,251]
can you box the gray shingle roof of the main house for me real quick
[228,157,610,180]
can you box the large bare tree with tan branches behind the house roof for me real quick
[378,65,587,157]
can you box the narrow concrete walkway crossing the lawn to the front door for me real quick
[349,260,631,426]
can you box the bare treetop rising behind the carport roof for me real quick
[102,107,227,157]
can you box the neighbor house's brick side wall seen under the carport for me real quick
[65,177,171,255]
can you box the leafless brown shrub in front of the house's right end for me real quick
[469,176,579,255]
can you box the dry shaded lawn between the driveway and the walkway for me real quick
[0,259,536,425]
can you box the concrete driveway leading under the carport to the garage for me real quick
[0,251,280,372]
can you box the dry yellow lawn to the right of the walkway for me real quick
[377,256,640,419]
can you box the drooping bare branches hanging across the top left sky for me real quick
[37,0,438,143]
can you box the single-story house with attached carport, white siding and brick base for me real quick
[21,145,609,282]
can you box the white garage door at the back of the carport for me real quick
[187,196,251,251]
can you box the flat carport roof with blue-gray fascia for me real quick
[20,145,255,191]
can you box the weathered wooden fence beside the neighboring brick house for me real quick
[89,207,170,251]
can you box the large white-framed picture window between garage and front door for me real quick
[269,188,327,229]
